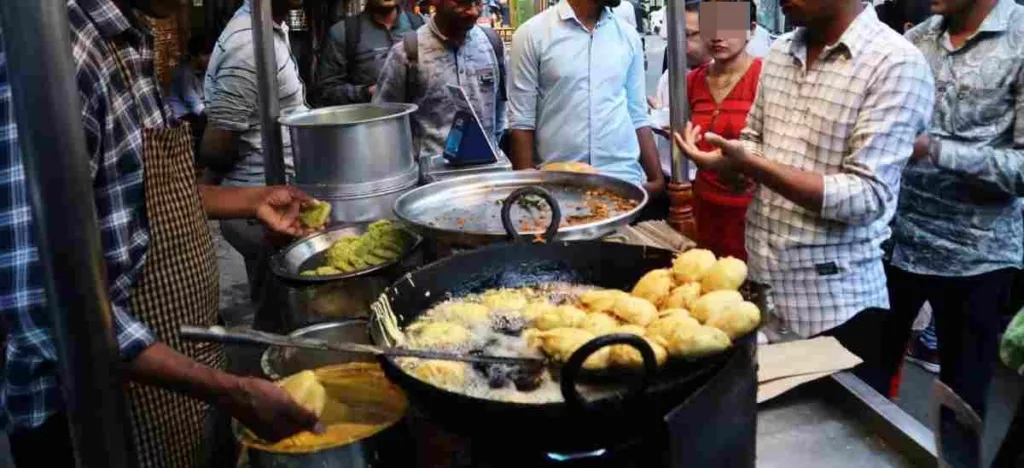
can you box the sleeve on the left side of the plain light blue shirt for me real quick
[508,28,540,130]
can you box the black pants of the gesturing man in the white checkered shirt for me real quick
[818,308,898,396]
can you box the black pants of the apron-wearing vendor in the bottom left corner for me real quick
[7,413,75,468]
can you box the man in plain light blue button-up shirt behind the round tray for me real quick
[509,0,665,195]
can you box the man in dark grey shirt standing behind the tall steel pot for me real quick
[310,0,423,107]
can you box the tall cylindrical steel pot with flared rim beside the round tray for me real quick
[281,103,420,222]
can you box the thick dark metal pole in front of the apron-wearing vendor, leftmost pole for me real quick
[0,0,134,468]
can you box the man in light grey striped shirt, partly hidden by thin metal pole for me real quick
[200,0,306,297]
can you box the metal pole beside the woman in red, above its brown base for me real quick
[665,0,690,183]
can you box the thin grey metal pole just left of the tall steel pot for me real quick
[251,0,287,185]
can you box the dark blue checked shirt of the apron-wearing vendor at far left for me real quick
[0,0,164,432]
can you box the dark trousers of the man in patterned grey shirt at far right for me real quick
[886,267,1016,466]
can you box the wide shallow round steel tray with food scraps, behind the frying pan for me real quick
[394,171,647,247]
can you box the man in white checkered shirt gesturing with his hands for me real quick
[676,0,935,392]
